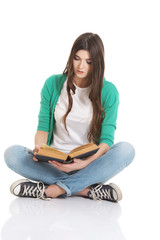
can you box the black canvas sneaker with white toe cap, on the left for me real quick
[10,179,48,200]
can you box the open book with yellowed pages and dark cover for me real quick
[36,142,99,163]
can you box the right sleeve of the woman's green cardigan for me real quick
[99,83,119,147]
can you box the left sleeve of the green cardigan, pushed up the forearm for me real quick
[37,78,52,132]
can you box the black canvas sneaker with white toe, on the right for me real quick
[88,183,122,202]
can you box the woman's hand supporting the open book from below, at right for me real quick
[48,158,88,172]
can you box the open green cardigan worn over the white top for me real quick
[37,74,119,146]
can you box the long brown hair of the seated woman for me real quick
[63,33,105,144]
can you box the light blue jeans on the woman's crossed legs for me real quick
[4,142,135,196]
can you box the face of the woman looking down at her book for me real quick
[73,50,92,79]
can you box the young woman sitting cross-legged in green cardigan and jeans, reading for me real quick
[4,33,135,202]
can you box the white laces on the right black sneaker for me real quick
[90,184,113,201]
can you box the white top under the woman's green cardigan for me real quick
[51,81,93,154]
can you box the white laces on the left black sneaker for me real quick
[22,182,48,200]
